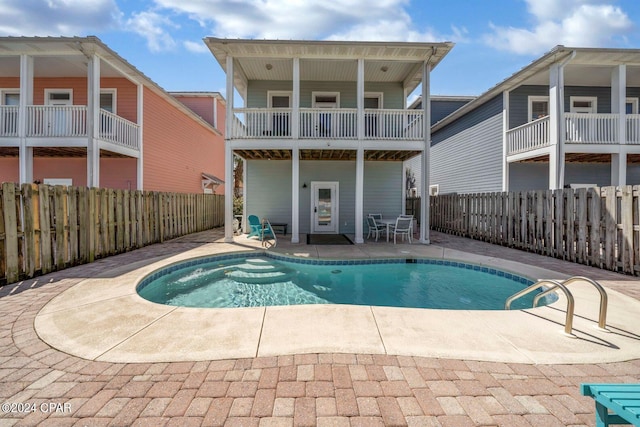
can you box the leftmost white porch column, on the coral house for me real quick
[18,55,33,184]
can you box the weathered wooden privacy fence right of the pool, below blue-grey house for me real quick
[430,186,640,275]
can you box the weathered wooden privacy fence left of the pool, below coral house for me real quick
[0,183,224,284]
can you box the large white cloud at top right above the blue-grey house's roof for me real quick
[484,0,634,55]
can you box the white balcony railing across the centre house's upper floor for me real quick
[229,108,424,141]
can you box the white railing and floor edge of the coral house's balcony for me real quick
[0,105,140,156]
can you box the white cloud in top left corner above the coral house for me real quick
[0,0,122,36]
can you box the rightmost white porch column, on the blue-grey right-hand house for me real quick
[611,64,627,186]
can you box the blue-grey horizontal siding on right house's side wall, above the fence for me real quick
[430,114,502,194]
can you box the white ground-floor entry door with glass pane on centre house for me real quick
[311,182,340,234]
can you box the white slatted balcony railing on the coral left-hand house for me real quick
[0,105,140,150]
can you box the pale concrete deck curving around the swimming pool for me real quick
[35,232,640,364]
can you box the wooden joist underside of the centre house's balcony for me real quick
[234,149,421,162]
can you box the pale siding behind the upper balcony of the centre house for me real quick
[247,80,405,109]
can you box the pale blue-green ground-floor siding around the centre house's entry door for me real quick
[246,160,402,234]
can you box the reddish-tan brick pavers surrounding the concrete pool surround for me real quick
[0,233,640,427]
